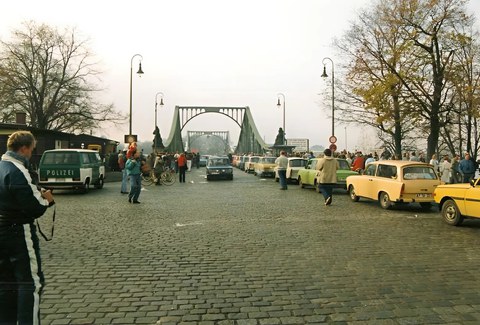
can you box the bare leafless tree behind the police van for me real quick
[0,22,124,132]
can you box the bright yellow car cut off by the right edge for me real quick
[433,178,480,226]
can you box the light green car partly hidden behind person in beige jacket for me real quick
[297,158,358,192]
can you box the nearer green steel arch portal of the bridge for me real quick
[165,106,268,154]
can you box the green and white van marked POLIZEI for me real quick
[38,149,105,193]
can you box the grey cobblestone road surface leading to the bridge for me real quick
[41,169,480,325]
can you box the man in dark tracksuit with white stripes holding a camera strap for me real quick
[0,131,54,324]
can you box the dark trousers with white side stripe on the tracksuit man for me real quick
[0,224,44,325]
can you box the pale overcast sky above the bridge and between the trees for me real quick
[0,0,480,150]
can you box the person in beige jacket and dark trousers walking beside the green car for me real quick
[316,148,339,205]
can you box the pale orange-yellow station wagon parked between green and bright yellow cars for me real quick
[347,160,441,209]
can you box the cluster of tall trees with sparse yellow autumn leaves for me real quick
[336,0,480,161]
